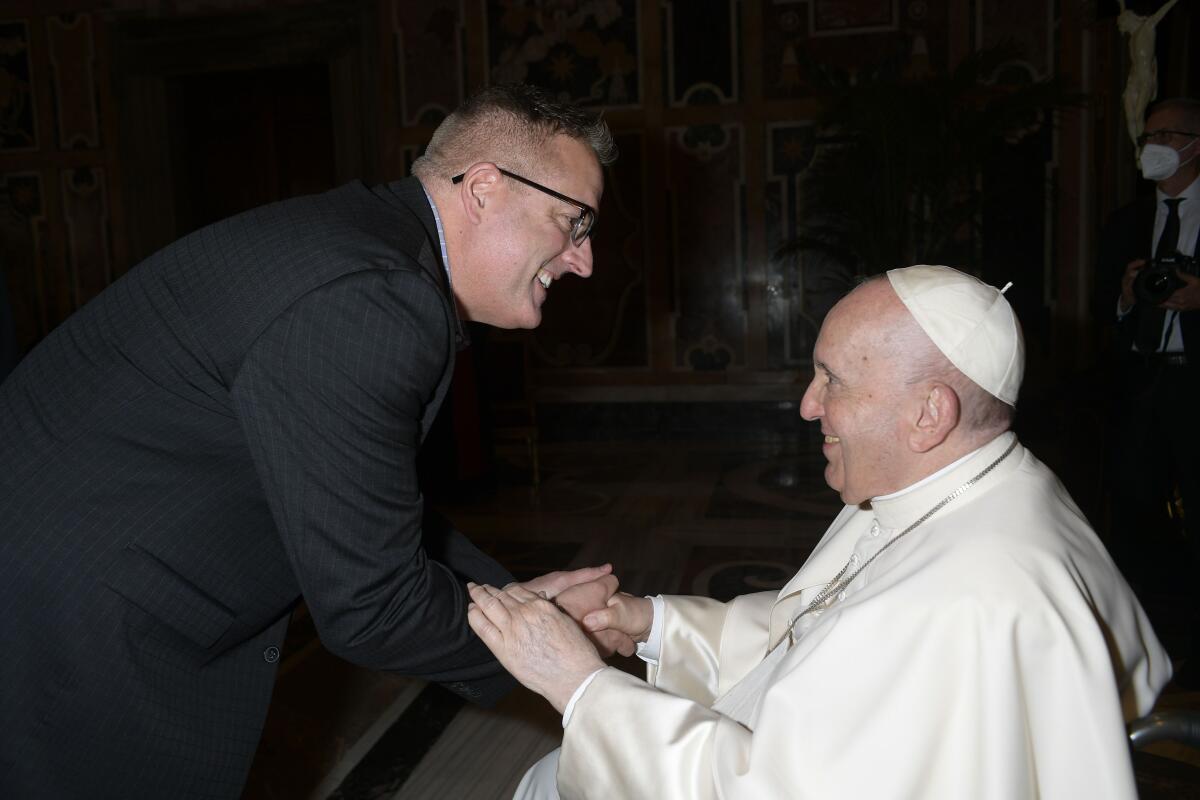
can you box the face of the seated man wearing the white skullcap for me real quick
[800,282,911,505]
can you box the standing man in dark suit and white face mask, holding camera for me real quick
[1097,98,1200,681]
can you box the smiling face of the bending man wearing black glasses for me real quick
[465,137,604,329]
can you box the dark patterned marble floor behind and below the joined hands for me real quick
[244,437,1200,800]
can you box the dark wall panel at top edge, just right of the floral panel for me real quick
[662,0,740,106]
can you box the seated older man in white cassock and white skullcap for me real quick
[469,266,1171,800]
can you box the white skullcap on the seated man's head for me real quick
[888,264,1025,407]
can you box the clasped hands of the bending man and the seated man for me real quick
[467,565,653,714]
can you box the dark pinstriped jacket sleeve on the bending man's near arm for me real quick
[233,270,511,694]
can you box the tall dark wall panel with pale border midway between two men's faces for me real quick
[666,125,749,371]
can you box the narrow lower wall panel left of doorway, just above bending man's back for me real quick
[61,167,113,308]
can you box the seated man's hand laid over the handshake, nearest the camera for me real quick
[467,583,604,714]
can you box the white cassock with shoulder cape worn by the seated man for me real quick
[526,433,1171,800]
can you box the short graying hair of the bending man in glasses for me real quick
[413,84,617,186]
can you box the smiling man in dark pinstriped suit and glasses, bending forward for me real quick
[0,86,631,800]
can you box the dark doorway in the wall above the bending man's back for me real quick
[167,64,336,235]
